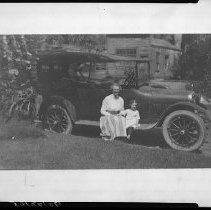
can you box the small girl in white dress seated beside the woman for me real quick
[121,99,140,139]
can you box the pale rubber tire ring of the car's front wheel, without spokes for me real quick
[162,110,206,152]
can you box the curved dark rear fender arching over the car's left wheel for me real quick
[40,96,77,123]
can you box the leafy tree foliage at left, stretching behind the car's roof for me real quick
[0,34,105,116]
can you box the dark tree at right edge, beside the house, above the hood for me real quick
[172,34,211,80]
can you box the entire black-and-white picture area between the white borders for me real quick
[0,34,211,169]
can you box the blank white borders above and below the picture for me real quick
[0,0,211,206]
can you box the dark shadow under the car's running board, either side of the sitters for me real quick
[72,125,167,148]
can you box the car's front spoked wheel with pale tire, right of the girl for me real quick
[163,110,206,151]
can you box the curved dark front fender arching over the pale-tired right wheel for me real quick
[156,102,207,127]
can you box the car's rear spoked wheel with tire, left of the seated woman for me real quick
[46,104,73,134]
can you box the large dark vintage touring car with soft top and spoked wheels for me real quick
[38,49,211,151]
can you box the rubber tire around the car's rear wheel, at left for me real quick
[45,101,73,134]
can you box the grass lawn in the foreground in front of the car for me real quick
[0,122,211,169]
